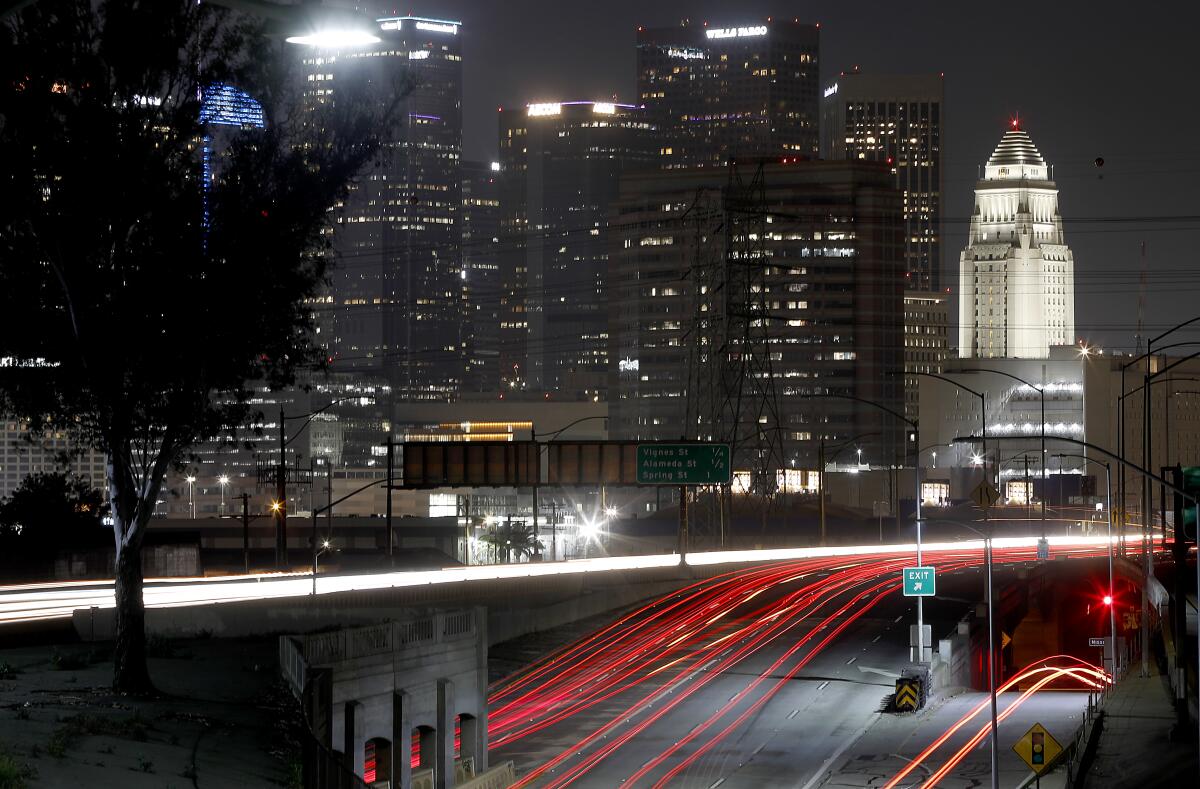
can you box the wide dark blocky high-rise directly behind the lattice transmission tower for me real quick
[608,161,906,469]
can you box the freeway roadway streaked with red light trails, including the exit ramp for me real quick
[488,547,1098,789]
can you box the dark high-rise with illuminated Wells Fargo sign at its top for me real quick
[637,19,821,168]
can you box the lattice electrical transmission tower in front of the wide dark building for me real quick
[685,162,784,547]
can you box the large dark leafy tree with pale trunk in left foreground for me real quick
[0,0,398,693]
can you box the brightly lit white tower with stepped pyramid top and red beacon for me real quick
[959,120,1075,359]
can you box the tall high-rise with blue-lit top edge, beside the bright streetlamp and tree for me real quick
[301,17,466,399]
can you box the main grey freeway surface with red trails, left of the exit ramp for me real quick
[490,549,1104,787]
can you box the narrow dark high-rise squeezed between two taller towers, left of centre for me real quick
[461,162,500,392]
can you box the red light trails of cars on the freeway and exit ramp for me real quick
[488,547,1097,787]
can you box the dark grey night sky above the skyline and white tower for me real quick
[398,0,1200,350]
